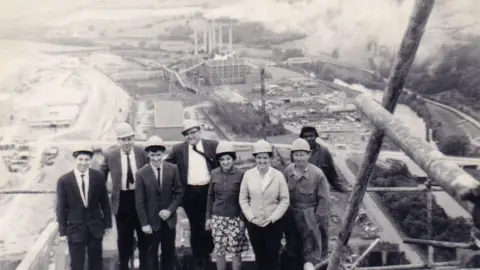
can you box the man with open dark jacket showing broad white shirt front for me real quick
[167,119,219,269]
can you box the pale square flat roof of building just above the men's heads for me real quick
[154,100,185,128]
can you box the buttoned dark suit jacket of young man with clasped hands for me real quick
[135,162,184,231]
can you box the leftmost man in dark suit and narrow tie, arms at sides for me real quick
[56,146,112,270]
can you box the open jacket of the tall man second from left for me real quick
[100,145,148,215]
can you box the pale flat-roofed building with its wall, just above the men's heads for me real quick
[153,100,185,141]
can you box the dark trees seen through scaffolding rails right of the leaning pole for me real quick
[347,159,471,261]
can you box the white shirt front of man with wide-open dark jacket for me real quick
[187,141,210,186]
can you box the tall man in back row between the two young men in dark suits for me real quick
[100,123,148,270]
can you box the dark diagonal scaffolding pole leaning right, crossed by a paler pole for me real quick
[327,0,435,270]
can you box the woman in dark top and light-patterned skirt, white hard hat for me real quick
[205,142,249,270]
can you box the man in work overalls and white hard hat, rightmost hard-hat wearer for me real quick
[284,138,330,269]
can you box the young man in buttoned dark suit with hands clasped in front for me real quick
[135,136,184,270]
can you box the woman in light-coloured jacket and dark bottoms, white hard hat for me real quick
[239,140,290,270]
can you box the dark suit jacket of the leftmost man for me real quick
[56,169,112,242]
